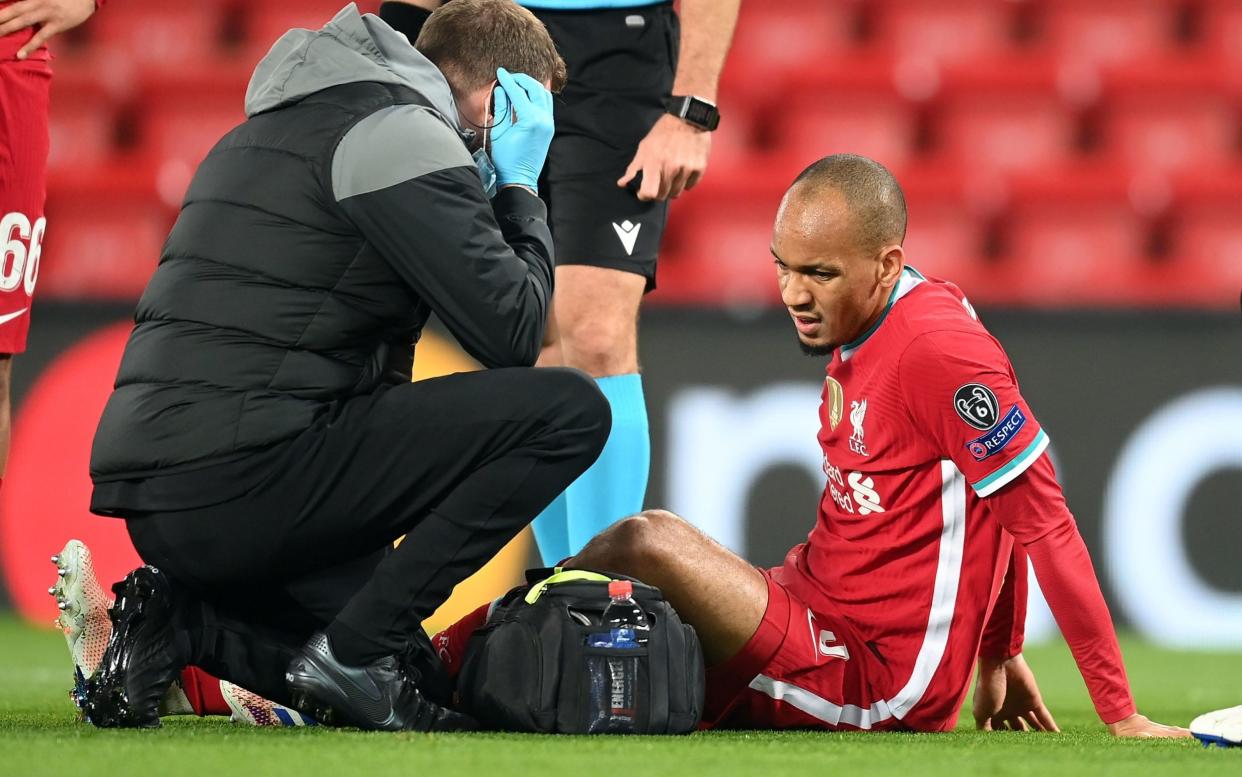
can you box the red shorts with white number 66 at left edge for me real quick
[0,60,52,354]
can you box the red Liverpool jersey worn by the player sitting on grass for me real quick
[782,268,1048,731]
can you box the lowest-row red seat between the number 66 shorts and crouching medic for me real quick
[39,168,173,299]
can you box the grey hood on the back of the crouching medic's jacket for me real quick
[246,2,461,132]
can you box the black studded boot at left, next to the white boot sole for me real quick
[83,566,186,729]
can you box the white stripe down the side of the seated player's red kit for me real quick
[750,459,966,729]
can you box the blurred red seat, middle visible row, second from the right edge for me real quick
[934,58,1079,173]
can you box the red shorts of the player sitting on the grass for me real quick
[703,567,900,730]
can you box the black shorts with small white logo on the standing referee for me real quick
[534,2,681,292]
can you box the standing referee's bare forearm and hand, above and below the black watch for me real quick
[618,0,741,200]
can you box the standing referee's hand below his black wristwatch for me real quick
[617,114,712,201]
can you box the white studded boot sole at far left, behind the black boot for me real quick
[47,540,112,710]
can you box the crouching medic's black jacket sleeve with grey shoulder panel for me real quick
[332,106,553,367]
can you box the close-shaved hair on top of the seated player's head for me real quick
[785,154,905,252]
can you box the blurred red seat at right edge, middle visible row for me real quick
[1100,60,1240,171]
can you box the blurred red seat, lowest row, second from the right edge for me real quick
[996,169,1149,307]
